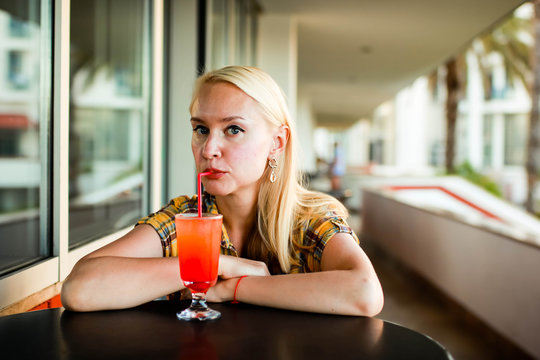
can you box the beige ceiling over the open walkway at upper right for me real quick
[259,0,524,125]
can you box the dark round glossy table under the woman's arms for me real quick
[0,301,452,360]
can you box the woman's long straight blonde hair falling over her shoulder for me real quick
[190,66,347,273]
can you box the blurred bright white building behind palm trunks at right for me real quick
[363,4,531,206]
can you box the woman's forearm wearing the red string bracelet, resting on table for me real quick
[217,270,383,316]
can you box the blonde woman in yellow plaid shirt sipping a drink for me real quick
[62,66,383,316]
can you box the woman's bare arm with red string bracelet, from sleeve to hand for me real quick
[209,233,384,316]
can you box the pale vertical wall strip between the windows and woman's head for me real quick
[167,0,197,199]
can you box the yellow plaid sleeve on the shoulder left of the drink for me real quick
[136,196,197,257]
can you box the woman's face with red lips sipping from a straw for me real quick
[191,82,275,196]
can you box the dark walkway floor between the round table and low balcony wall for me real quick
[349,212,532,360]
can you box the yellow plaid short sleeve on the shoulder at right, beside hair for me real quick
[297,215,360,272]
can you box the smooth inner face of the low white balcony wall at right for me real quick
[362,191,540,358]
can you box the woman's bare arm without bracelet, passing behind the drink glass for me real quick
[62,225,268,311]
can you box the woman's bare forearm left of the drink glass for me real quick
[62,256,182,311]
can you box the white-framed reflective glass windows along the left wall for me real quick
[0,0,168,309]
